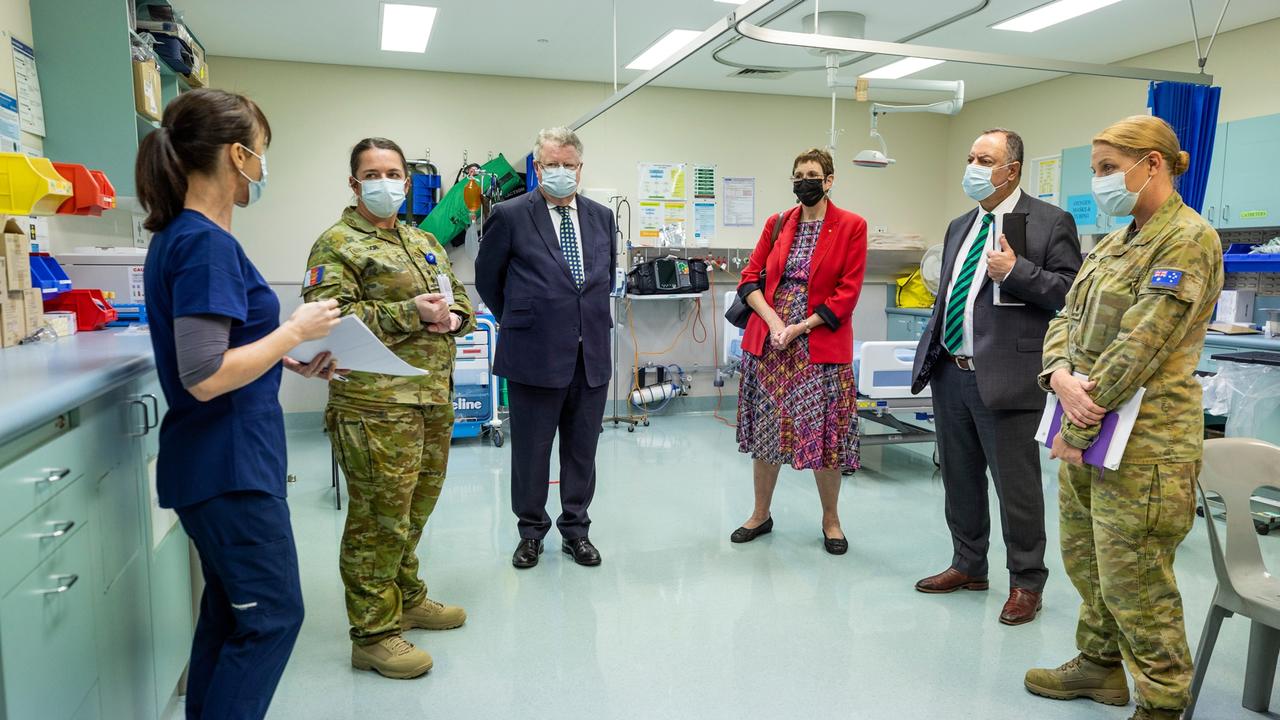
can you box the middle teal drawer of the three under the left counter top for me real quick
[0,468,92,593]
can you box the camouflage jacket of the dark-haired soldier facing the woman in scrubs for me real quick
[302,208,475,405]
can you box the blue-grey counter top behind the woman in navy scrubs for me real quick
[0,329,155,443]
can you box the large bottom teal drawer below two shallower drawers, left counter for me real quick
[0,527,97,720]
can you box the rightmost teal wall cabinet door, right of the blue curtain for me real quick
[1219,115,1280,228]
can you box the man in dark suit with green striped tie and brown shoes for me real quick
[911,128,1080,625]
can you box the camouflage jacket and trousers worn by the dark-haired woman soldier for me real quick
[302,208,475,644]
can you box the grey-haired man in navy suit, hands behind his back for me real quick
[476,128,617,568]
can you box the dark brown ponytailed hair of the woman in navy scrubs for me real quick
[134,88,271,232]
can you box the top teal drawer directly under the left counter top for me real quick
[0,413,86,530]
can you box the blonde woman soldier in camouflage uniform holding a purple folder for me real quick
[1025,115,1222,720]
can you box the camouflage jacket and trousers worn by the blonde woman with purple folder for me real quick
[1039,192,1222,710]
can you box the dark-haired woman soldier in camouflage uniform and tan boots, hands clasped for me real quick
[302,138,474,678]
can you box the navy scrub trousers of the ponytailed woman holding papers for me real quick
[177,492,302,720]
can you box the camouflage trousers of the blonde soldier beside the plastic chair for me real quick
[1059,462,1201,710]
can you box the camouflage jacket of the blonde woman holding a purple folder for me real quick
[1039,192,1222,464]
